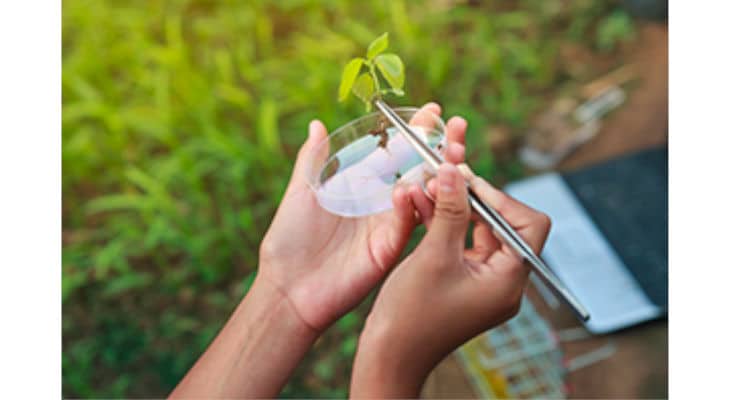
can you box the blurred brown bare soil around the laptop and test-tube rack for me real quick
[423,23,668,398]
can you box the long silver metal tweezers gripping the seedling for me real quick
[375,99,590,321]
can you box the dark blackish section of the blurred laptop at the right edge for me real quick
[563,147,668,309]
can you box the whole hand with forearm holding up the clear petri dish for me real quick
[171,104,465,398]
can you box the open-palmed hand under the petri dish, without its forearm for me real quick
[259,103,464,332]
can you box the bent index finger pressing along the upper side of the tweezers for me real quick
[469,176,550,253]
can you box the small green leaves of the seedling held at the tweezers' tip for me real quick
[338,32,405,111]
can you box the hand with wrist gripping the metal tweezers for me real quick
[351,136,550,397]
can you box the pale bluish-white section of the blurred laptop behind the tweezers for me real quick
[506,173,661,333]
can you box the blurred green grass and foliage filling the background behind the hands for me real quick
[62,0,630,397]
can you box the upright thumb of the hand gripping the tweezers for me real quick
[426,163,471,251]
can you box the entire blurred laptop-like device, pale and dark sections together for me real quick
[506,147,667,333]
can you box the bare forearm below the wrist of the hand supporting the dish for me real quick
[170,278,317,398]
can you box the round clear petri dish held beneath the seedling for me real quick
[308,107,446,217]
